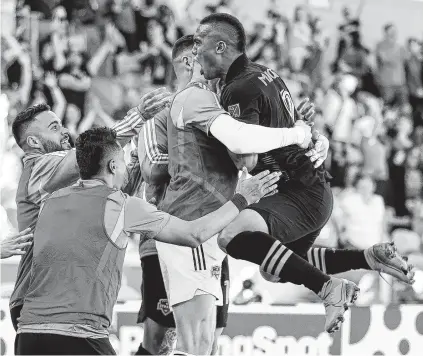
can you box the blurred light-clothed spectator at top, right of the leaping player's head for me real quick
[288,6,312,72]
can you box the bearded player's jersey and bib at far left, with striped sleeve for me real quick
[9,109,144,308]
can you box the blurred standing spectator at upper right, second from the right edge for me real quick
[376,24,408,107]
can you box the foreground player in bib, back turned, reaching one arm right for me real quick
[15,128,280,355]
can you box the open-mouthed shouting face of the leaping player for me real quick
[192,25,223,80]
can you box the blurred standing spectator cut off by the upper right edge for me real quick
[406,38,423,127]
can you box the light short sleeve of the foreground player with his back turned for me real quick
[124,196,170,239]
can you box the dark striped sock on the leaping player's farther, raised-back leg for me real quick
[305,247,370,274]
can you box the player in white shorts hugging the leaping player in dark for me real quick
[151,36,330,354]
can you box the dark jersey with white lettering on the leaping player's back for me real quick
[221,55,326,185]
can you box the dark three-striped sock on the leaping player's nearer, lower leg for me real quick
[226,231,330,294]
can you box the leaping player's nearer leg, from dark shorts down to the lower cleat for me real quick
[219,185,358,332]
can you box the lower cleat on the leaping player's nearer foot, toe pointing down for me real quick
[318,277,360,334]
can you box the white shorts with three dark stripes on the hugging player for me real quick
[156,235,226,309]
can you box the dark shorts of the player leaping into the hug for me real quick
[248,182,333,255]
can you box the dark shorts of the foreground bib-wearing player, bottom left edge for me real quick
[15,333,116,355]
